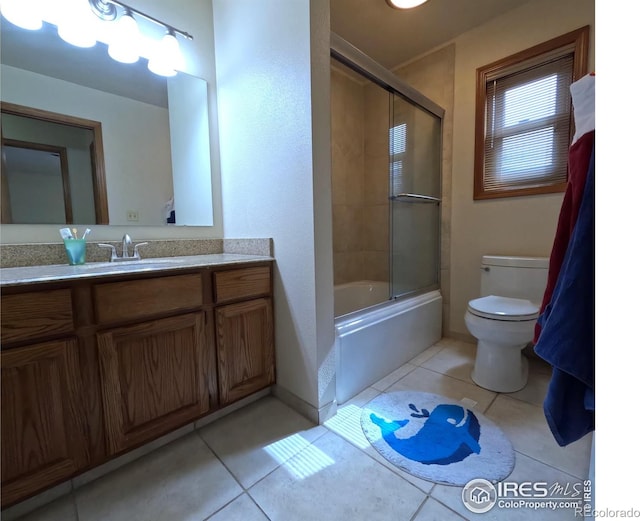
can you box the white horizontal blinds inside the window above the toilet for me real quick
[483,52,573,191]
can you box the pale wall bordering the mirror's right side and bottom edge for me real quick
[0,0,223,244]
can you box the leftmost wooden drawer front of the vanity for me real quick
[2,289,73,344]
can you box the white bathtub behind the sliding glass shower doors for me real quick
[334,280,442,404]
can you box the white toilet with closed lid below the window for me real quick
[464,255,549,393]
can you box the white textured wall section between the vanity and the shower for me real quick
[214,0,335,414]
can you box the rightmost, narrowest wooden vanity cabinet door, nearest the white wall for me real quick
[216,298,275,406]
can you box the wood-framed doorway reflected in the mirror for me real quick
[0,102,109,224]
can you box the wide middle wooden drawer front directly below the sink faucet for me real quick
[94,273,202,323]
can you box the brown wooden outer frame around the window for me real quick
[473,25,589,200]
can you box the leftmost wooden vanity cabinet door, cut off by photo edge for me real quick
[0,339,89,507]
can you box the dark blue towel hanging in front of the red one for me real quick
[534,140,595,446]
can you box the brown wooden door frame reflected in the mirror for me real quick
[0,101,109,224]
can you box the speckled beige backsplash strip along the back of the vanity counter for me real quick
[0,237,273,268]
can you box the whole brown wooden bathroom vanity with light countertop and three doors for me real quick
[0,254,275,508]
